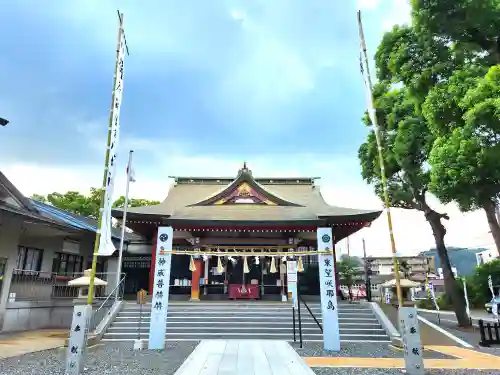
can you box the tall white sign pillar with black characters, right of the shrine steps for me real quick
[317,228,340,351]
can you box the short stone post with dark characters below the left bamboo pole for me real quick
[66,305,92,375]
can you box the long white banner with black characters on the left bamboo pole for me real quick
[98,25,125,256]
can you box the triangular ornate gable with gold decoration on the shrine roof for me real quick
[191,163,301,207]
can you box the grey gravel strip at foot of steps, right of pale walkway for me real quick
[292,342,454,359]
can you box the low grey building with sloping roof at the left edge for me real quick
[0,172,145,331]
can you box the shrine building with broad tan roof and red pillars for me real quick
[113,163,381,300]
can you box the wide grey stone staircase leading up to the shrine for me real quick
[103,301,390,342]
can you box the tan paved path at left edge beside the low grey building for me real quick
[0,330,68,358]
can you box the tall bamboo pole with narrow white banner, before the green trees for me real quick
[358,11,403,307]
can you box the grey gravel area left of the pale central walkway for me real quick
[0,341,198,375]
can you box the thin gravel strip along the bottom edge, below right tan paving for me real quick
[312,368,499,375]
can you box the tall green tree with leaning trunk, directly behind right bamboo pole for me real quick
[359,27,470,326]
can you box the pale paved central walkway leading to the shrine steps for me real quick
[175,340,314,375]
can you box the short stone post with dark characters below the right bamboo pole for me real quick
[399,307,425,375]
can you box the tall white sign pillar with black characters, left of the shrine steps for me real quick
[148,227,174,349]
